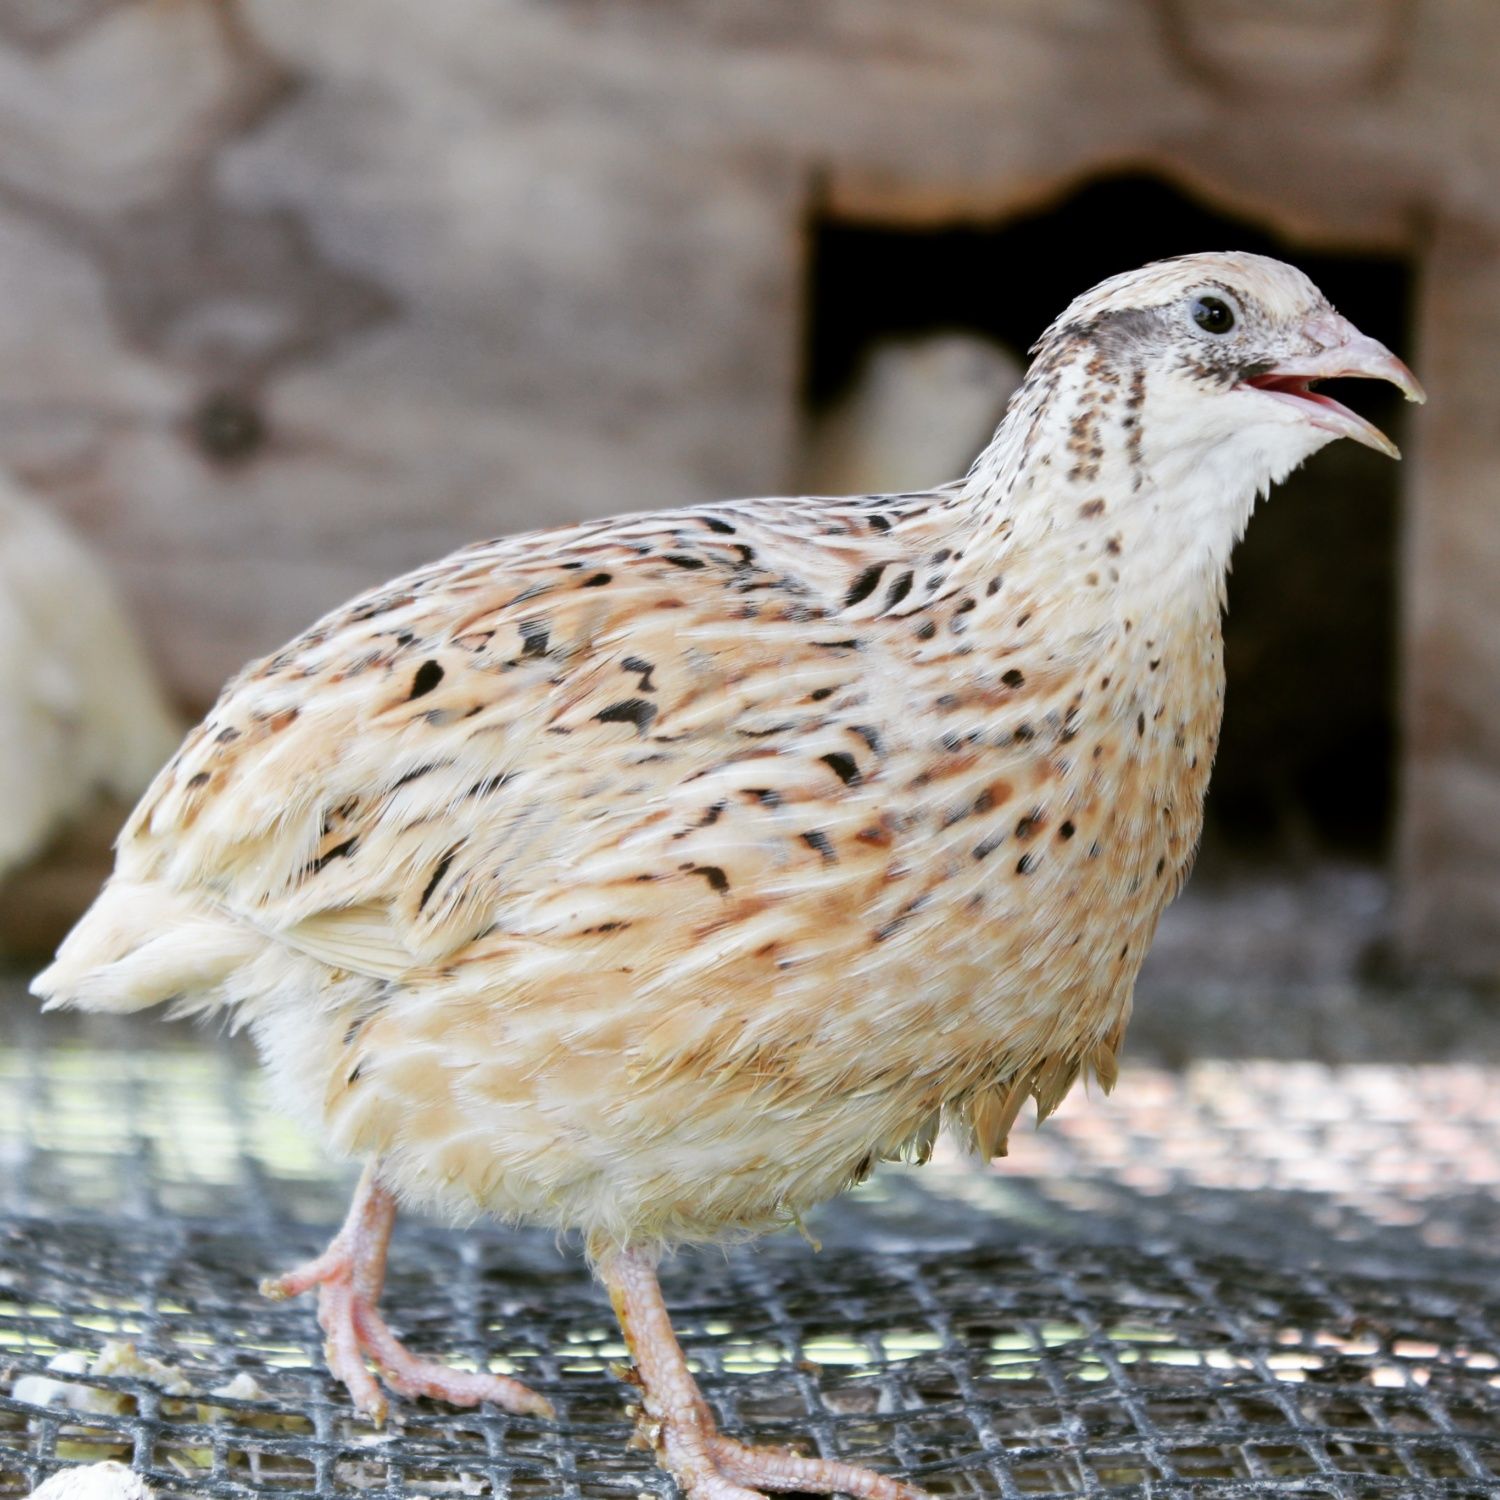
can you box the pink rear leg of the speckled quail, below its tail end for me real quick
[261,1163,552,1425]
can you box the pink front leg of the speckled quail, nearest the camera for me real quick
[599,1250,926,1500]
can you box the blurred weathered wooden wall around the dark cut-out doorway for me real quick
[0,0,1500,972]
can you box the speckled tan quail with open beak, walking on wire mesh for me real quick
[35,252,1425,1500]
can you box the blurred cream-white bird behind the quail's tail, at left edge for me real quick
[0,476,180,876]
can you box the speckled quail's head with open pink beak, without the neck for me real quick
[1035,254,1425,489]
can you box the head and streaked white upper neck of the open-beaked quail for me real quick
[966,254,1425,569]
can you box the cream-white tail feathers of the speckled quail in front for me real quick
[32,876,264,1013]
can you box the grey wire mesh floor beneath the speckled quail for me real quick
[0,999,1500,1500]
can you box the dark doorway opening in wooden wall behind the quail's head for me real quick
[804,176,1412,866]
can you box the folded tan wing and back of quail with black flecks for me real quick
[119,501,936,977]
